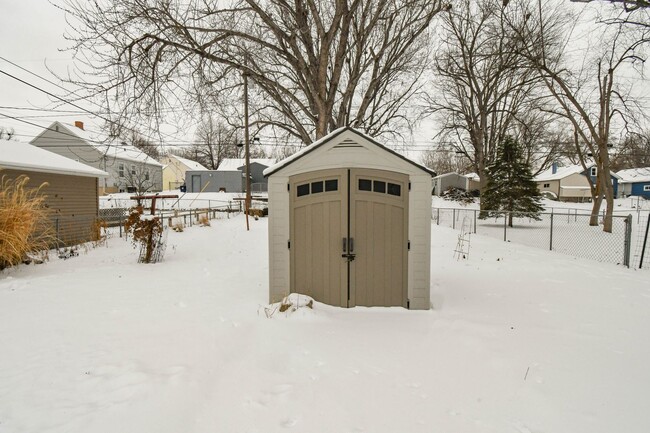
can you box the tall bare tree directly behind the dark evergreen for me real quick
[428,0,538,205]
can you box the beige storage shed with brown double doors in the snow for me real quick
[264,127,434,310]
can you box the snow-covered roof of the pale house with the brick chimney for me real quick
[31,121,163,167]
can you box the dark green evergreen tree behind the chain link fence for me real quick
[480,136,544,227]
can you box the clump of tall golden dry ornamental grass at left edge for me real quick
[0,175,55,269]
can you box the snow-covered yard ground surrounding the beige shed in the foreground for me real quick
[0,216,650,433]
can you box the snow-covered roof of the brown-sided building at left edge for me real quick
[0,140,108,177]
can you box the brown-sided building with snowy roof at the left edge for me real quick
[0,140,108,245]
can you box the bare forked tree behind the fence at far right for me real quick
[512,3,642,232]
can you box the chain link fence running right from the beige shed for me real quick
[431,208,632,267]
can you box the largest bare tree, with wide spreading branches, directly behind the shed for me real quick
[59,0,448,143]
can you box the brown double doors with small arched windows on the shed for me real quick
[289,169,408,307]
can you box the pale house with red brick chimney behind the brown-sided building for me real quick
[30,122,163,195]
